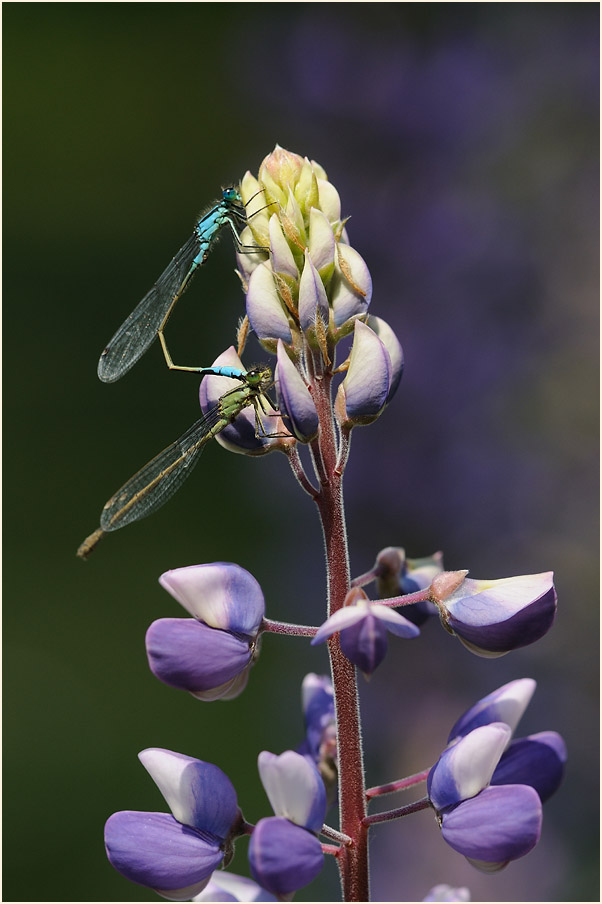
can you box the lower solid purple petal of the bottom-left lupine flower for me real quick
[105,810,223,901]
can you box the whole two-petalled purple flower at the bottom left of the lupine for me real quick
[105,748,240,901]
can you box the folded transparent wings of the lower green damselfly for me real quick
[100,407,227,531]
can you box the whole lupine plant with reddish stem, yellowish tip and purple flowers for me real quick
[95,147,566,901]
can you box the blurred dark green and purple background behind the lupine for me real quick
[3,3,599,901]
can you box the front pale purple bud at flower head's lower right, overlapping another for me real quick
[335,320,393,427]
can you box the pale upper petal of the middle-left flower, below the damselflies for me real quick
[159,562,265,637]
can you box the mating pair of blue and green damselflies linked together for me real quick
[77,188,276,559]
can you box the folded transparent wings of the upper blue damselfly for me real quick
[98,233,201,383]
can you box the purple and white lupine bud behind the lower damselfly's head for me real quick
[199,346,292,455]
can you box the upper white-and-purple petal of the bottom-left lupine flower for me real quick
[138,747,238,843]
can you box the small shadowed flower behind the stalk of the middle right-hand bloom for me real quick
[374,546,443,626]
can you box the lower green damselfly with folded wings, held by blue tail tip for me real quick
[77,365,275,559]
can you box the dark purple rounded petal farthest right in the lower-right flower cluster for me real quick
[491,731,567,803]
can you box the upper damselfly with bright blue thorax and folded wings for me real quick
[98,188,268,383]
